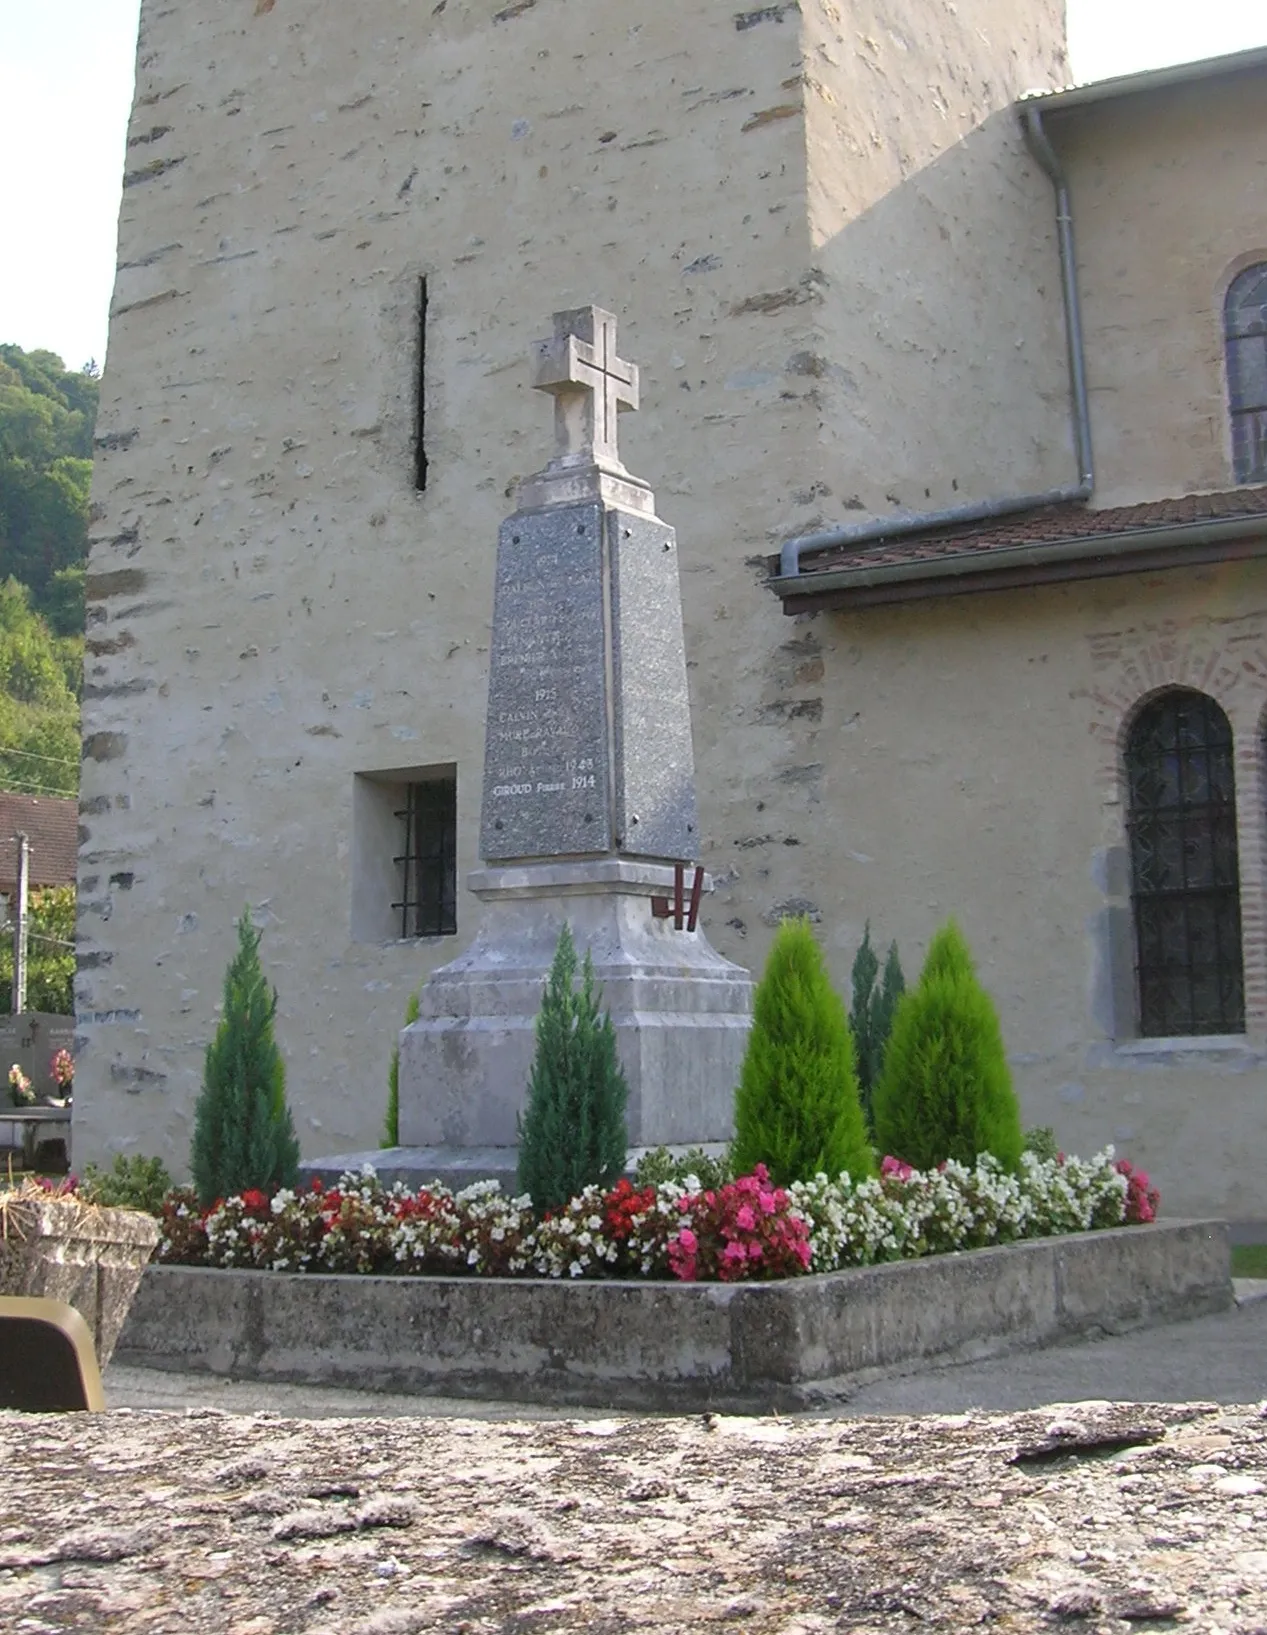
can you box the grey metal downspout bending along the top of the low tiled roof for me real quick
[778,103,1095,579]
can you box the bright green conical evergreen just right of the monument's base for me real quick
[731,919,875,1185]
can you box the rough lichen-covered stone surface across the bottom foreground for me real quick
[0,1403,1267,1635]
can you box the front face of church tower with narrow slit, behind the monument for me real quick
[77,0,817,1166]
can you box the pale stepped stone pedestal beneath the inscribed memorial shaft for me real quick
[399,857,752,1174]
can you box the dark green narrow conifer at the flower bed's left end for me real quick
[190,909,299,1205]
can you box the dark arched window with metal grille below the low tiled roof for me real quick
[1126,688,1244,1038]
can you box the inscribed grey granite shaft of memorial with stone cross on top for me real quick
[481,307,698,862]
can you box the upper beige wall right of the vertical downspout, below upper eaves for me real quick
[1051,74,1267,505]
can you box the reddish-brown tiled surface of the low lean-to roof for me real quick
[801,487,1267,579]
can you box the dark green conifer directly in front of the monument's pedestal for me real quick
[518,922,629,1212]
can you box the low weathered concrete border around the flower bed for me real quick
[116,1221,1231,1409]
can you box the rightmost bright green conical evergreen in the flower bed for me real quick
[873,921,1023,1169]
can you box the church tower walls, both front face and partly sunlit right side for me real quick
[75,0,1064,1171]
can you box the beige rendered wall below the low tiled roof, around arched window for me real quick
[791,562,1267,1221]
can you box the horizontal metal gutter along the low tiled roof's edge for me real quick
[770,513,1267,598]
